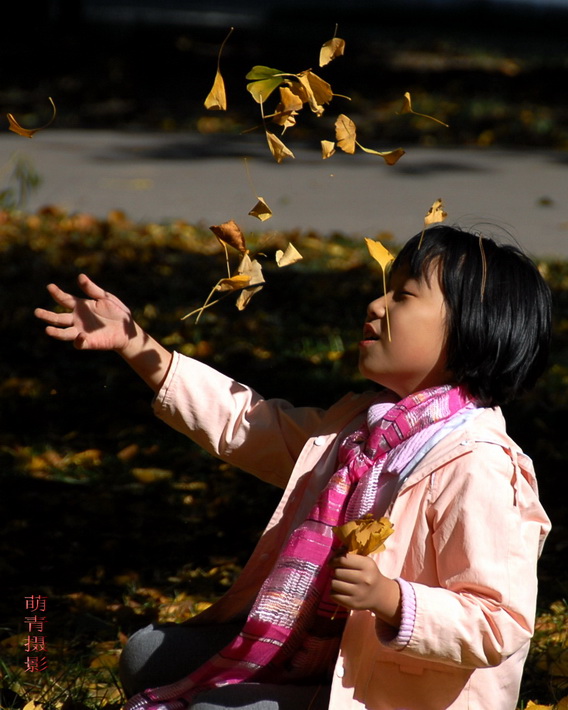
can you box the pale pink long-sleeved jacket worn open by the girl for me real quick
[154,354,550,710]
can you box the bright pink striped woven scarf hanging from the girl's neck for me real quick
[125,385,471,710]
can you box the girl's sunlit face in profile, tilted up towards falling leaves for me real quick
[359,265,452,397]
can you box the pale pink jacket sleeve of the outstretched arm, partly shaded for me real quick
[153,353,325,488]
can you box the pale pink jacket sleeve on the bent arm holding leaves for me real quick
[390,443,549,668]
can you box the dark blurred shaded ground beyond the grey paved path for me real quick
[0,0,568,148]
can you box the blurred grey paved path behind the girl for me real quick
[0,130,568,257]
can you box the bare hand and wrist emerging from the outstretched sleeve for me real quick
[34,274,172,392]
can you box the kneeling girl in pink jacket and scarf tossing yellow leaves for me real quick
[36,226,550,710]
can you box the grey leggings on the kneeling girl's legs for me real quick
[119,624,330,710]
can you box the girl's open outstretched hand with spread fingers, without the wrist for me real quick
[34,274,136,351]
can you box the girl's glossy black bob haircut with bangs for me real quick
[392,225,552,407]
